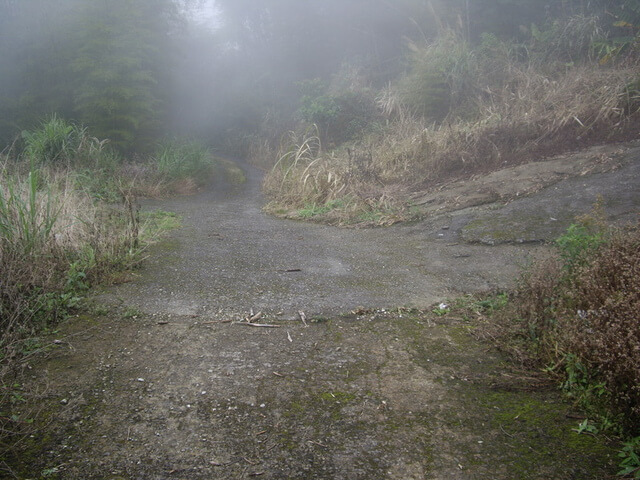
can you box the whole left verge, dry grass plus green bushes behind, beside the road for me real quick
[0,116,242,464]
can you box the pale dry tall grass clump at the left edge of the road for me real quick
[0,168,137,344]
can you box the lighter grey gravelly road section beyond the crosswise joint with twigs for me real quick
[100,164,534,318]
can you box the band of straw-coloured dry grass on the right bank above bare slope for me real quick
[265,53,640,224]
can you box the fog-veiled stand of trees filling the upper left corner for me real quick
[0,0,182,150]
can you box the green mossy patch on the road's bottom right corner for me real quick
[448,384,616,480]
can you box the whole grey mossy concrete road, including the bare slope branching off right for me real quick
[11,142,640,480]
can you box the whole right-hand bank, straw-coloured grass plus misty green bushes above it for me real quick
[254,17,639,225]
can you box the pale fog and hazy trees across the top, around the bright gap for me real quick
[0,0,633,154]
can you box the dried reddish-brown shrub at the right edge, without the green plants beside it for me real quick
[560,230,640,435]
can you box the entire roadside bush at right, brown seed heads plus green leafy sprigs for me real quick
[516,219,640,436]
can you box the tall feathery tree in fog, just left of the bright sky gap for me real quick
[72,0,174,149]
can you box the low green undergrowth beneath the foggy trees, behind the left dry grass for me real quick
[18,115,244,203]
